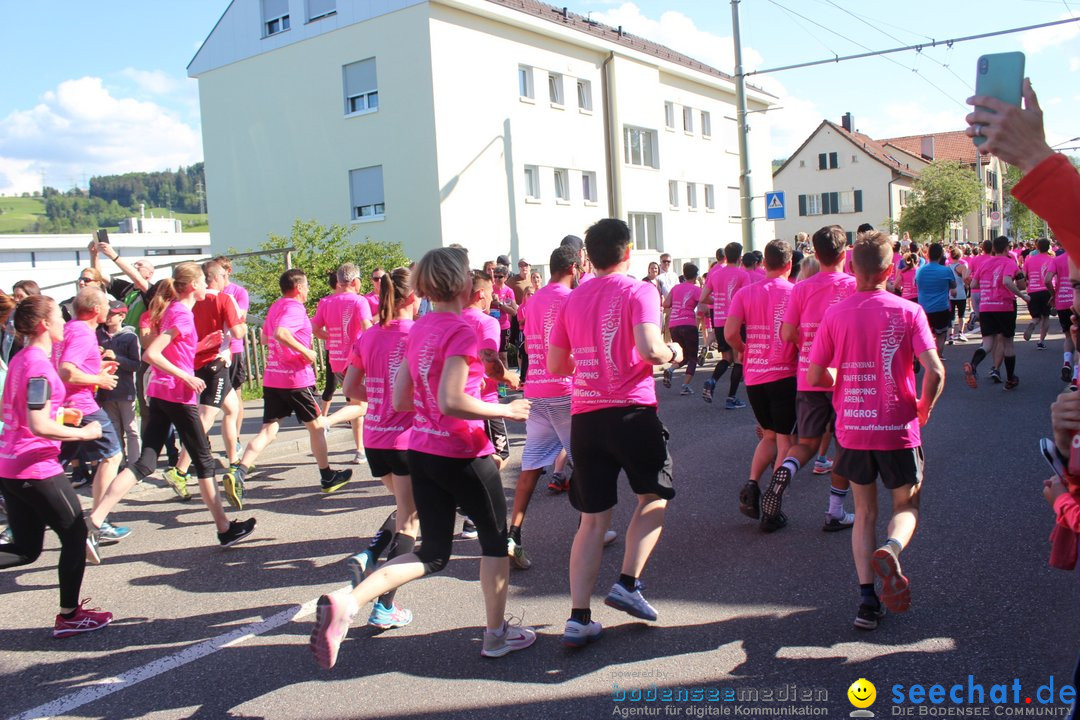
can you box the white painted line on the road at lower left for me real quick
[11,599,336,720]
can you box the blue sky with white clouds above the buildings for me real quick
[0,0,1080,194]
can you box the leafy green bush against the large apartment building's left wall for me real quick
[230,220,409,315]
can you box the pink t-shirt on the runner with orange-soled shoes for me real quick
[810,290,934,450]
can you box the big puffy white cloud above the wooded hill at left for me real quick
[0,73,202,194]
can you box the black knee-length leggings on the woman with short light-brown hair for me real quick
[408,450,507,574]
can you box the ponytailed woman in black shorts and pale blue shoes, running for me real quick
[339,268,420,629]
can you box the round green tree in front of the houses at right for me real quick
[900,160,984,240]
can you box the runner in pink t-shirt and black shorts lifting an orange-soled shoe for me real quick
[807,232,945,630]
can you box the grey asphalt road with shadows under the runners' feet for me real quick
[0,328,1080,720]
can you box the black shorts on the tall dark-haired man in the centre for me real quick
[569,405,675,513]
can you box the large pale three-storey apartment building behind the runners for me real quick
[188,0,777,274]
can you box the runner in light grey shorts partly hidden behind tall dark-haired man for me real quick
[507,245,579,570]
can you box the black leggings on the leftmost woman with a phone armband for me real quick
[0,474,86,608]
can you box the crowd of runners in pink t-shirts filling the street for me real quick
[0,76,1080,690]
